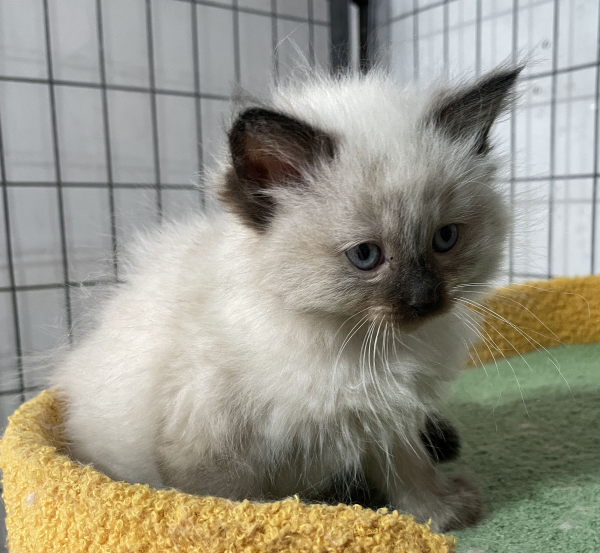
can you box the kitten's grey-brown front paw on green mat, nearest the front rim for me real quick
[432,476,483,532]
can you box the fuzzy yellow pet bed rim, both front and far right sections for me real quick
[0,277,600,553]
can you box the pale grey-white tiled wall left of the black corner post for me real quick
[0,0,329,542]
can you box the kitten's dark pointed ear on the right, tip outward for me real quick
[428,65,523,155]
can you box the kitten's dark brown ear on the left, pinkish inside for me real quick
[220,108,335,231]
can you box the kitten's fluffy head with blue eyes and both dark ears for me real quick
[220,67,521,328]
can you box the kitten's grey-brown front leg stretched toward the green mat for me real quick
[367,442,483,532]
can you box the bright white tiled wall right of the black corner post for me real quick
[378,0,600,280]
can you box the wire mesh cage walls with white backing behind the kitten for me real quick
[0,0,600,548]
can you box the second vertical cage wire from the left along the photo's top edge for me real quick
[96,0,119,280]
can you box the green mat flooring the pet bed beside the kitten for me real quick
[448,344,600,553]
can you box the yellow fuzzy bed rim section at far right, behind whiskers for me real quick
[472,276,600,365]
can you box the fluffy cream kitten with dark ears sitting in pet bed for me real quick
[52,63,521,530]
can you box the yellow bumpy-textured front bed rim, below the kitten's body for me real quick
[0,391,454,553]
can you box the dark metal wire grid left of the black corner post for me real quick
[0,0,329,414]
